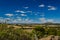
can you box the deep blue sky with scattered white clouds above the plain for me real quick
[0,0,60,23]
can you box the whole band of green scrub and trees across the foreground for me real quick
[0,24,60,40]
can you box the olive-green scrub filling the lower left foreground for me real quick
[0,26,32,40]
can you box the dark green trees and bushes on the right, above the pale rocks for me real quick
[34,26,60,39]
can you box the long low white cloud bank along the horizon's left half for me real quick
[0,17,33,23]
